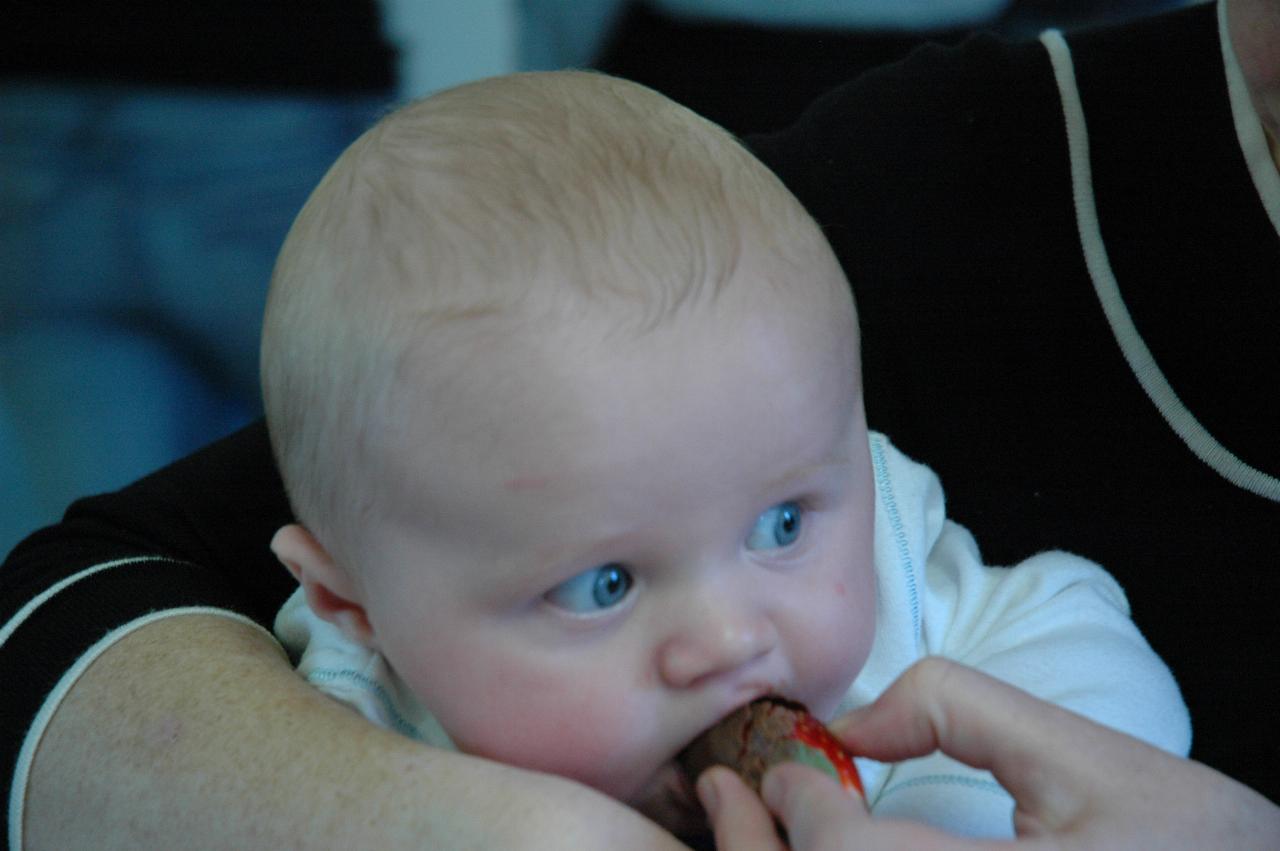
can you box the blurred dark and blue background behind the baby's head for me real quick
[0,0,1178,554]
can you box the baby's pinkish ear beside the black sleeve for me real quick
[271,523,375,648]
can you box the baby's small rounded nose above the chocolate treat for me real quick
[658,605,778,688]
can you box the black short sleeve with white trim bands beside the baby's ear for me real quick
[0,424,291,838]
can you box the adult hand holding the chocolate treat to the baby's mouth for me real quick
[698,659,1280,851]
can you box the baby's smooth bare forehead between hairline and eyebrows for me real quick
[373,278,859,563]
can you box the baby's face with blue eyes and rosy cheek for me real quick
[360,244,876,802]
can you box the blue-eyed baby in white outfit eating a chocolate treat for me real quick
[262,72,1189,836]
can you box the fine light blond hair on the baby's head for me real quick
[262,72,820,562]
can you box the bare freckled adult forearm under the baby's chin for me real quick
[22,616,681,848]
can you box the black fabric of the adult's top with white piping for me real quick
[0,6,1280,834]
